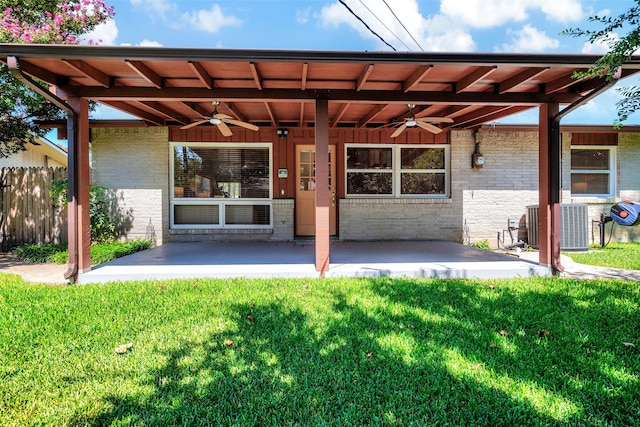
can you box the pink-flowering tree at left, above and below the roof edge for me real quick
[0,0,114,157]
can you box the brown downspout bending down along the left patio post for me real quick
[7,56,78,280]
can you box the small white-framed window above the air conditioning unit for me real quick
[571,145,616,197]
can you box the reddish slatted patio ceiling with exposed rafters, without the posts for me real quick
[5,44,640,128]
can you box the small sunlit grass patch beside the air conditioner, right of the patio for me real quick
[565,242,640,270]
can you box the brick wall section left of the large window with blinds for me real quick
[91,127,169,245]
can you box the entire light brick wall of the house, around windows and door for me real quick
[92,128,640,247]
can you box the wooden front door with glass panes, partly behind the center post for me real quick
[296,145,336,236]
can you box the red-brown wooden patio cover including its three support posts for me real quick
[5,44,640,279]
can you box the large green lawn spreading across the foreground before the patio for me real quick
[0,275,640,426]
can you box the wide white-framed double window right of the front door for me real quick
[346,144,449,197]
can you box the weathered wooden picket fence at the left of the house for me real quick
[0,167,67,251]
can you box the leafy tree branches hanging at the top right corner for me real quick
[562,0,640,126]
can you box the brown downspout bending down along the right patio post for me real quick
[550,67,622,272]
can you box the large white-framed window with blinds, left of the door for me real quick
[170,143,273,229]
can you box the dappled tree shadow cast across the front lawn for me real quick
[73,279,640,426]
